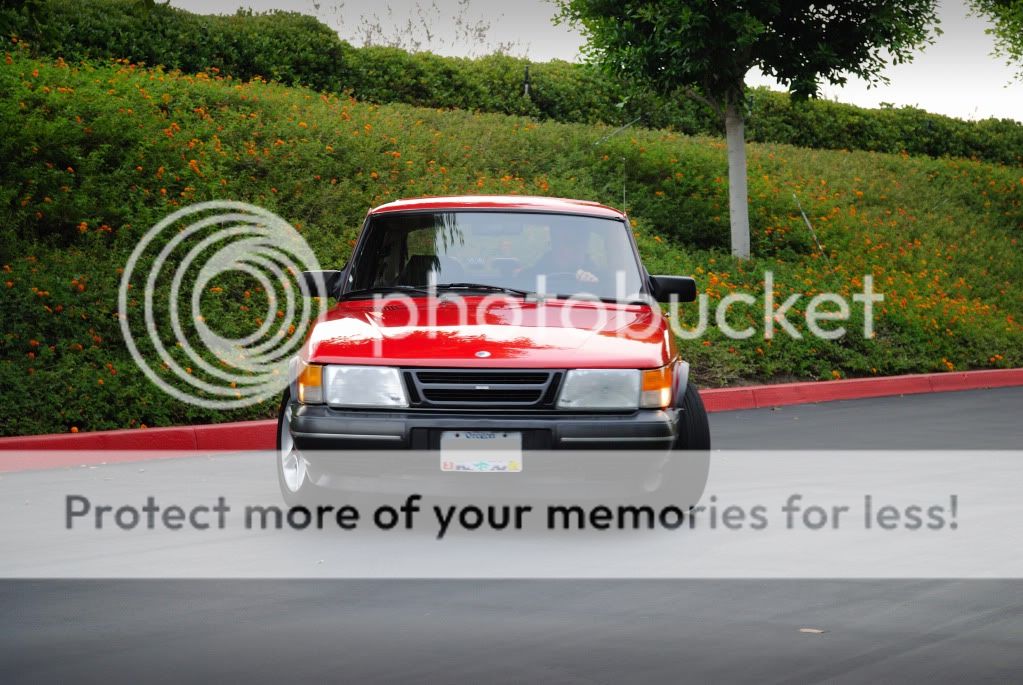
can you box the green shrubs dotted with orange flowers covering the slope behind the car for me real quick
[0,49,1023,435]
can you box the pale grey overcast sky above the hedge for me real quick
[171,0,1023,122]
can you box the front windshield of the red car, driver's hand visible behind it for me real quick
[348,212,641,300]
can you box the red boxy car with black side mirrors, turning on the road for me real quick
[277,196,710,503]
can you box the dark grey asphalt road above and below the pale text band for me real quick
[0,389,1023,683]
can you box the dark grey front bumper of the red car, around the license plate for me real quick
[291,404,679,498]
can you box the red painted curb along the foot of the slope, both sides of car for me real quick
[0,369,1023,472]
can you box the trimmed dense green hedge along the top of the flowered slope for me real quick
[0,0,1023,165]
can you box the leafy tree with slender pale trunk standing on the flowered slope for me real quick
[555,0,940,259]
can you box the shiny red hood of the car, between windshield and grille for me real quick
[303,296,674,368]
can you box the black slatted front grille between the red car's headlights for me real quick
[402,369,562,409]
